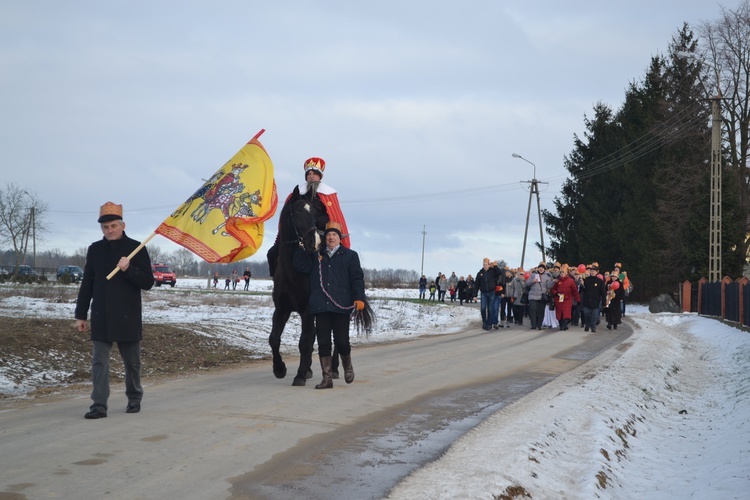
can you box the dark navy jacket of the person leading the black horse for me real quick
[292,245,365,314]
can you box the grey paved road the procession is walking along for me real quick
[0,325,631,500]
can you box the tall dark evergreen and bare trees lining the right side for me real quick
[542,0,750,290]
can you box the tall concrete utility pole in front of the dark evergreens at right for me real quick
[708,93,721,282]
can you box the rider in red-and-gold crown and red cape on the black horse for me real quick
[266,156,351,277]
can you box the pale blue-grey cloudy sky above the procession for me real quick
[0,0,739,276]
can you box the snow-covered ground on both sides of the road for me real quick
[0,280,750,499]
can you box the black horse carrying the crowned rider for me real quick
[268,187,374,386]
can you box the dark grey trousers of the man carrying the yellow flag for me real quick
[91,340,143,411]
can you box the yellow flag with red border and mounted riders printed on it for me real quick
[155,130,279,263]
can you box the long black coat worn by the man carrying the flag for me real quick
[75,233,154,342]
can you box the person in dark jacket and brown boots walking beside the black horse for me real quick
[292,221,365,389]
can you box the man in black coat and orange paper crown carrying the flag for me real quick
[75,201,154,419]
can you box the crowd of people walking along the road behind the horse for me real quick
[419,258,633,332]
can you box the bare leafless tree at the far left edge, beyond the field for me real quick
[0,183,47,269]
